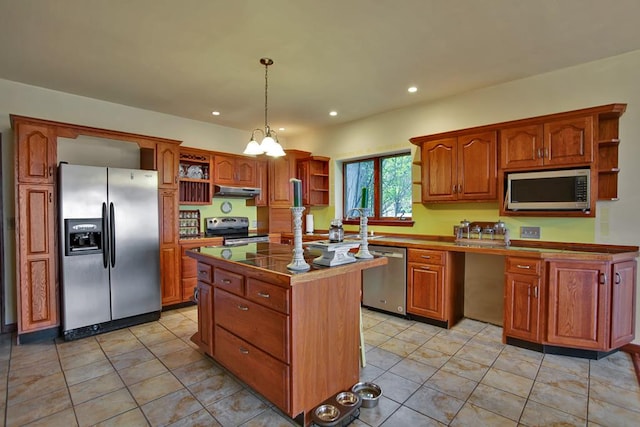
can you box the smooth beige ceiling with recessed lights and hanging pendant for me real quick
[0,0,640,135]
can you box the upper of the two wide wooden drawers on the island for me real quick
[214,288,289,363]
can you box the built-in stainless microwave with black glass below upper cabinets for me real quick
[505,169,591,211]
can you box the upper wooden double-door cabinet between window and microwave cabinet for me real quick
[421,132,497,202]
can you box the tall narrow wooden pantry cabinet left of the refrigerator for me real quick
[12,117,60,334]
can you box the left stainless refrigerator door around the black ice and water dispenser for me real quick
[58,164,111,331]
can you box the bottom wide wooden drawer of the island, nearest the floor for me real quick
[215,326,289,413]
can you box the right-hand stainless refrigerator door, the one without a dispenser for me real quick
[108,168,161,320]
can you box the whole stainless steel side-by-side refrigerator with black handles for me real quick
[58,163,161,340]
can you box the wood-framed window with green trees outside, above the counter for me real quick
[343,153,412,225]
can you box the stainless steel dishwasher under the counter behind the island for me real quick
[362,245,407,316]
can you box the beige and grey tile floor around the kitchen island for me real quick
[0,307,640,427]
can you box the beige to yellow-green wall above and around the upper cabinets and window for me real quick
[0,51,640,342]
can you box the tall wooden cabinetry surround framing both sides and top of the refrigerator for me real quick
[10,114,181,340]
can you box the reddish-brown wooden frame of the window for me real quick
[342,151,414,227]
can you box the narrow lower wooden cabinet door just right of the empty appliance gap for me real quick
[504,274,542,342]
